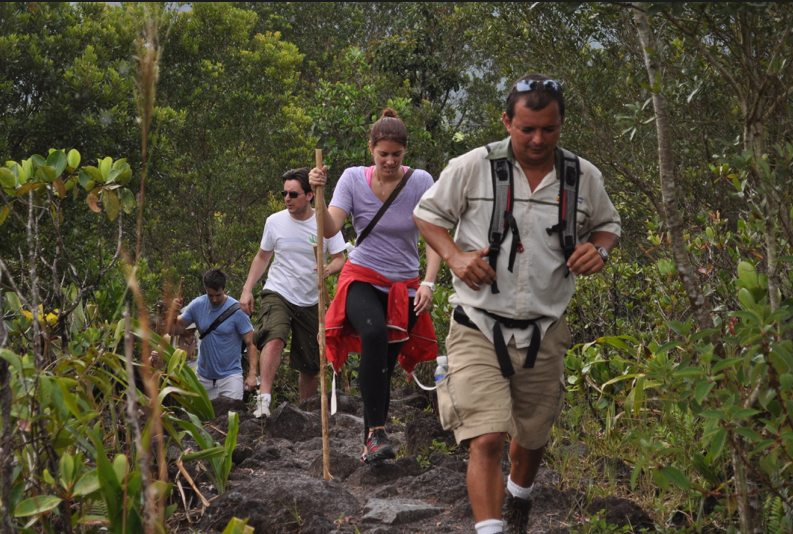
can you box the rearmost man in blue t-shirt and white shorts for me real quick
[176,269,259,400]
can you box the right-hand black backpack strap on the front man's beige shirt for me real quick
[546,147,581,276]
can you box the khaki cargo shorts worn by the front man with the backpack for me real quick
[438,317,572,450]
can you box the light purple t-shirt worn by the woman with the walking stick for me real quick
[330,167,434,294]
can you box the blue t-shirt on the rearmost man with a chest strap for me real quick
[182,295,253,380]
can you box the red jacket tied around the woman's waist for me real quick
[325,261,438,373]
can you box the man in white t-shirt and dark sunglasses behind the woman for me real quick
[240,168,346,417]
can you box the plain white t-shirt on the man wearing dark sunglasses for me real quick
[261,210,344,308]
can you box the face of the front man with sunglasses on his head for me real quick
[502,99,564,167]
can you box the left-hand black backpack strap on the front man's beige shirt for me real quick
[485,146,520,294]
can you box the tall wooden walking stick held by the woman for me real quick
[314,148,333,480]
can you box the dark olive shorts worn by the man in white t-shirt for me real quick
[253,289,319,376]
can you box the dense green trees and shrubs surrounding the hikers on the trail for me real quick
[0,2,793,534]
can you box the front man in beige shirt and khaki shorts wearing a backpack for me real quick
[414,74,620,534]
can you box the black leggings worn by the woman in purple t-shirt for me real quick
[347,282,416,442]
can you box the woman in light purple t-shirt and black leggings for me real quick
[309,108,441,463]
